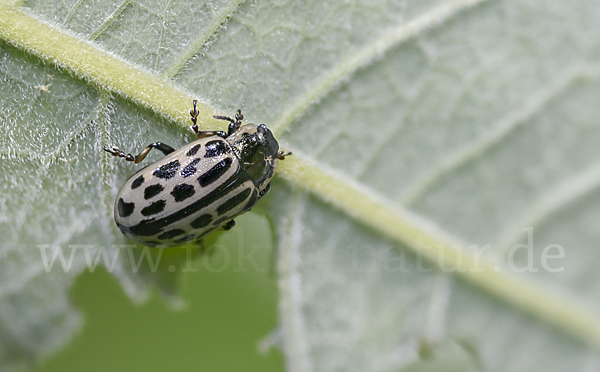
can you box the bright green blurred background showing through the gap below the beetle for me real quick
[35,213,283,372]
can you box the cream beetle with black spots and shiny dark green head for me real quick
[104,100,291,247]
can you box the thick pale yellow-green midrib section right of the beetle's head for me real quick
[278,149,600,346]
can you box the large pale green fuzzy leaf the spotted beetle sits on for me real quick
[0,0,600,371]
